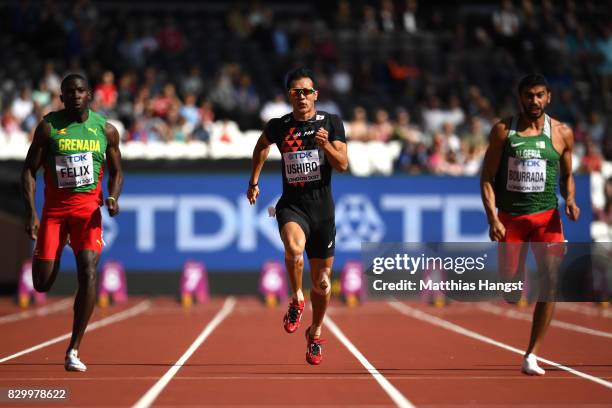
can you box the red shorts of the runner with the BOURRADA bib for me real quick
[498,208,565,278]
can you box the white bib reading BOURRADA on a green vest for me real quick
[506,157,546,193]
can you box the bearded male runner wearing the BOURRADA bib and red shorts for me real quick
[480,74,580,375]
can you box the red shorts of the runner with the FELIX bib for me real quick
[34,202,104,260]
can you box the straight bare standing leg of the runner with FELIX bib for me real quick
[68,249,100,350]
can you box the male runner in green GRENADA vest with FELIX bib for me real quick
[22,74,123,371]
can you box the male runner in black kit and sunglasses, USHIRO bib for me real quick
[247,68,348,364]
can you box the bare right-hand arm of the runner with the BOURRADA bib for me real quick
[553,123,580,221]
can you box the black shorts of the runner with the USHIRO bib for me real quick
[276,195,336,259]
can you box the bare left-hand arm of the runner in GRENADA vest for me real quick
[21,120,51,240]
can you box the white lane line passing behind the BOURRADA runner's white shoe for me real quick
[387,301,612,389]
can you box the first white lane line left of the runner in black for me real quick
[133,297,236,408]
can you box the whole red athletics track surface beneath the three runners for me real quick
[0,298,612,407]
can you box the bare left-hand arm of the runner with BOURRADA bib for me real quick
[480,121,508,241]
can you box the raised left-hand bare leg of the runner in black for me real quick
[281,221,306,302]
